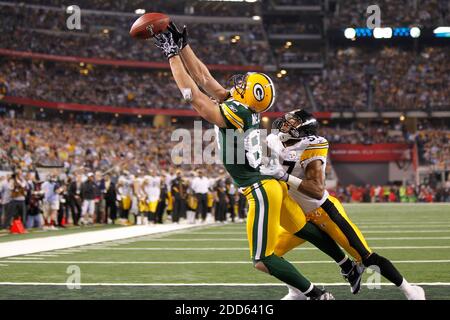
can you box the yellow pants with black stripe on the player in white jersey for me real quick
[275,196,372,262]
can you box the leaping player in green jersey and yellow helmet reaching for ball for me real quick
[150,24,370,300]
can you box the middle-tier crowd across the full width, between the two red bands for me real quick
[0,44,450,111]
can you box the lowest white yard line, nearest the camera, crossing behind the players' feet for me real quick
[0,282,450,287]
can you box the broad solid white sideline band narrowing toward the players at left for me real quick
[0,224,215,258]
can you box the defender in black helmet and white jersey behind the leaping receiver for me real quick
[261,110,425,300]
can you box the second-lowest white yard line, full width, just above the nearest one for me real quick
[0,258,450,265]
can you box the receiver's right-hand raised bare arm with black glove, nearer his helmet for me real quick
[168,22,228,102]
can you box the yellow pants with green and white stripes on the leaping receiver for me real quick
[243,179,306,261]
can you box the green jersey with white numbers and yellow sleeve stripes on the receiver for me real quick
[216,99,270,187]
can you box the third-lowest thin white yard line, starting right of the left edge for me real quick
[84,246,450,251]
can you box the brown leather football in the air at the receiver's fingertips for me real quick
[130,12,170,39]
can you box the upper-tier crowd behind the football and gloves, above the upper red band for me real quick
[0,6,273,65]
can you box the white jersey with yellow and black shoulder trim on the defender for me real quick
[267,133,329,213]
